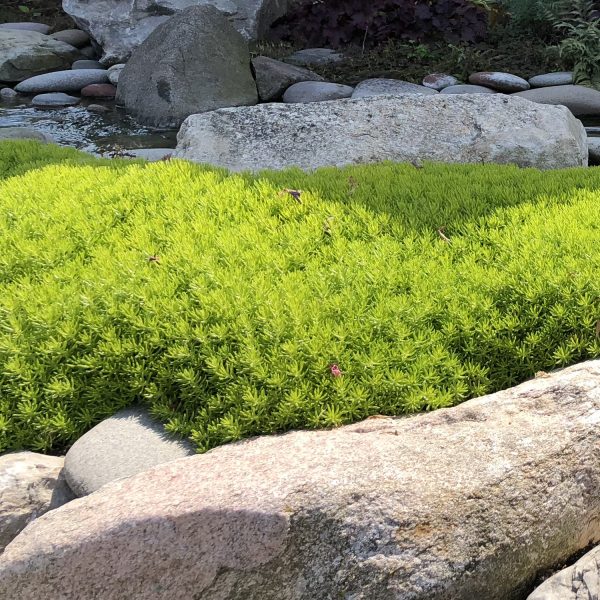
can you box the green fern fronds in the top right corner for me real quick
[539,0,600,85]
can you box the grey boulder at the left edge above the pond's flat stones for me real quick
[0,29,79,82]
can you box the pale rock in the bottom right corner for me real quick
[527,546,600,600]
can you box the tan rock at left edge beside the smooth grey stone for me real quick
[0,450,75,552]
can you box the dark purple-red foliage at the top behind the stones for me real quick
[272,0,487,48]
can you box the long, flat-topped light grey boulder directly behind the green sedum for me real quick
[175,94,588,171]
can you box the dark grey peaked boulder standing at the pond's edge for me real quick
[117,6,258,127]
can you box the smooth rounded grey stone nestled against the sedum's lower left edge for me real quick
[65,408,195,496]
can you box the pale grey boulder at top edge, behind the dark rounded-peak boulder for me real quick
[63,0,296,64]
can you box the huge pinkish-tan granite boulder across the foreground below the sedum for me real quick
[0,361,600,600]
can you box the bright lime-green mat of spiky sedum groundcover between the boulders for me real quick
[0,142,600,451]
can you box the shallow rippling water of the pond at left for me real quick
[0,98,177,155]
